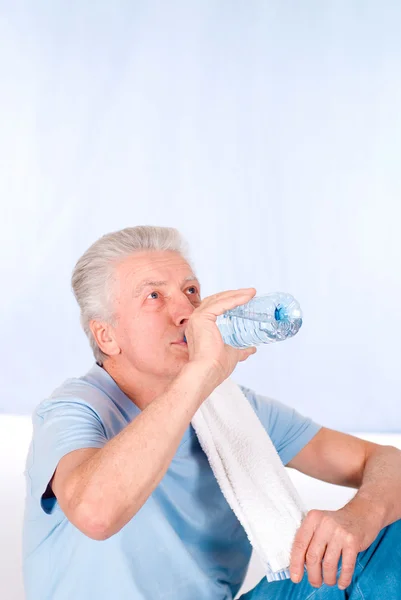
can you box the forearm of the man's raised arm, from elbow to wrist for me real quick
[70,365,210,539]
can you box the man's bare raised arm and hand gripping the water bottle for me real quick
[52,288,256,540]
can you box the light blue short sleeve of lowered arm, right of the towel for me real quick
[239,385,322,465]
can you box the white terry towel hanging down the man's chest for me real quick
[191,378,307,581]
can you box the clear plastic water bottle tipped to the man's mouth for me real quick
[183,292,302,348]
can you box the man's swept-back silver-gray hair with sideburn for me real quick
[71,225,193,365]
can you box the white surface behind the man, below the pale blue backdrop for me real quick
[0,416,401,600]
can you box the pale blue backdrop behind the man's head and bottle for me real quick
[0,0,401,432]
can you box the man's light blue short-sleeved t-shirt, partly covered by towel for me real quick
[23,364,321,600]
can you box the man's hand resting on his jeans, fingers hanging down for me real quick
[290,505,380,589]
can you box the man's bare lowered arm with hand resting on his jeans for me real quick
[286,427,401,589]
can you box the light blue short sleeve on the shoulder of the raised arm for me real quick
[26,398,107,514]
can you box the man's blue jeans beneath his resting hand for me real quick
[239,519,401,600]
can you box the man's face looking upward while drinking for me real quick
[110,251,201,379]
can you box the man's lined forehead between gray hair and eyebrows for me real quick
[117,251,194,285]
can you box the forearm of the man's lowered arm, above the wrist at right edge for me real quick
[348,446,401,531]
